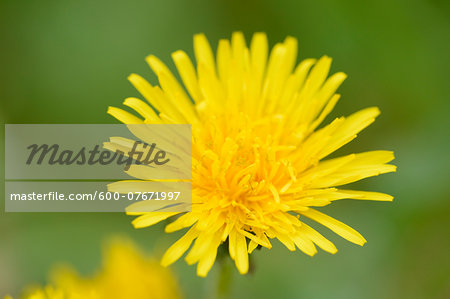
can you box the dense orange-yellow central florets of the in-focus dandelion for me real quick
[193,113,295,216]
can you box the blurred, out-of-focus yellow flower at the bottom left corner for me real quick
[5,239,181,299]
